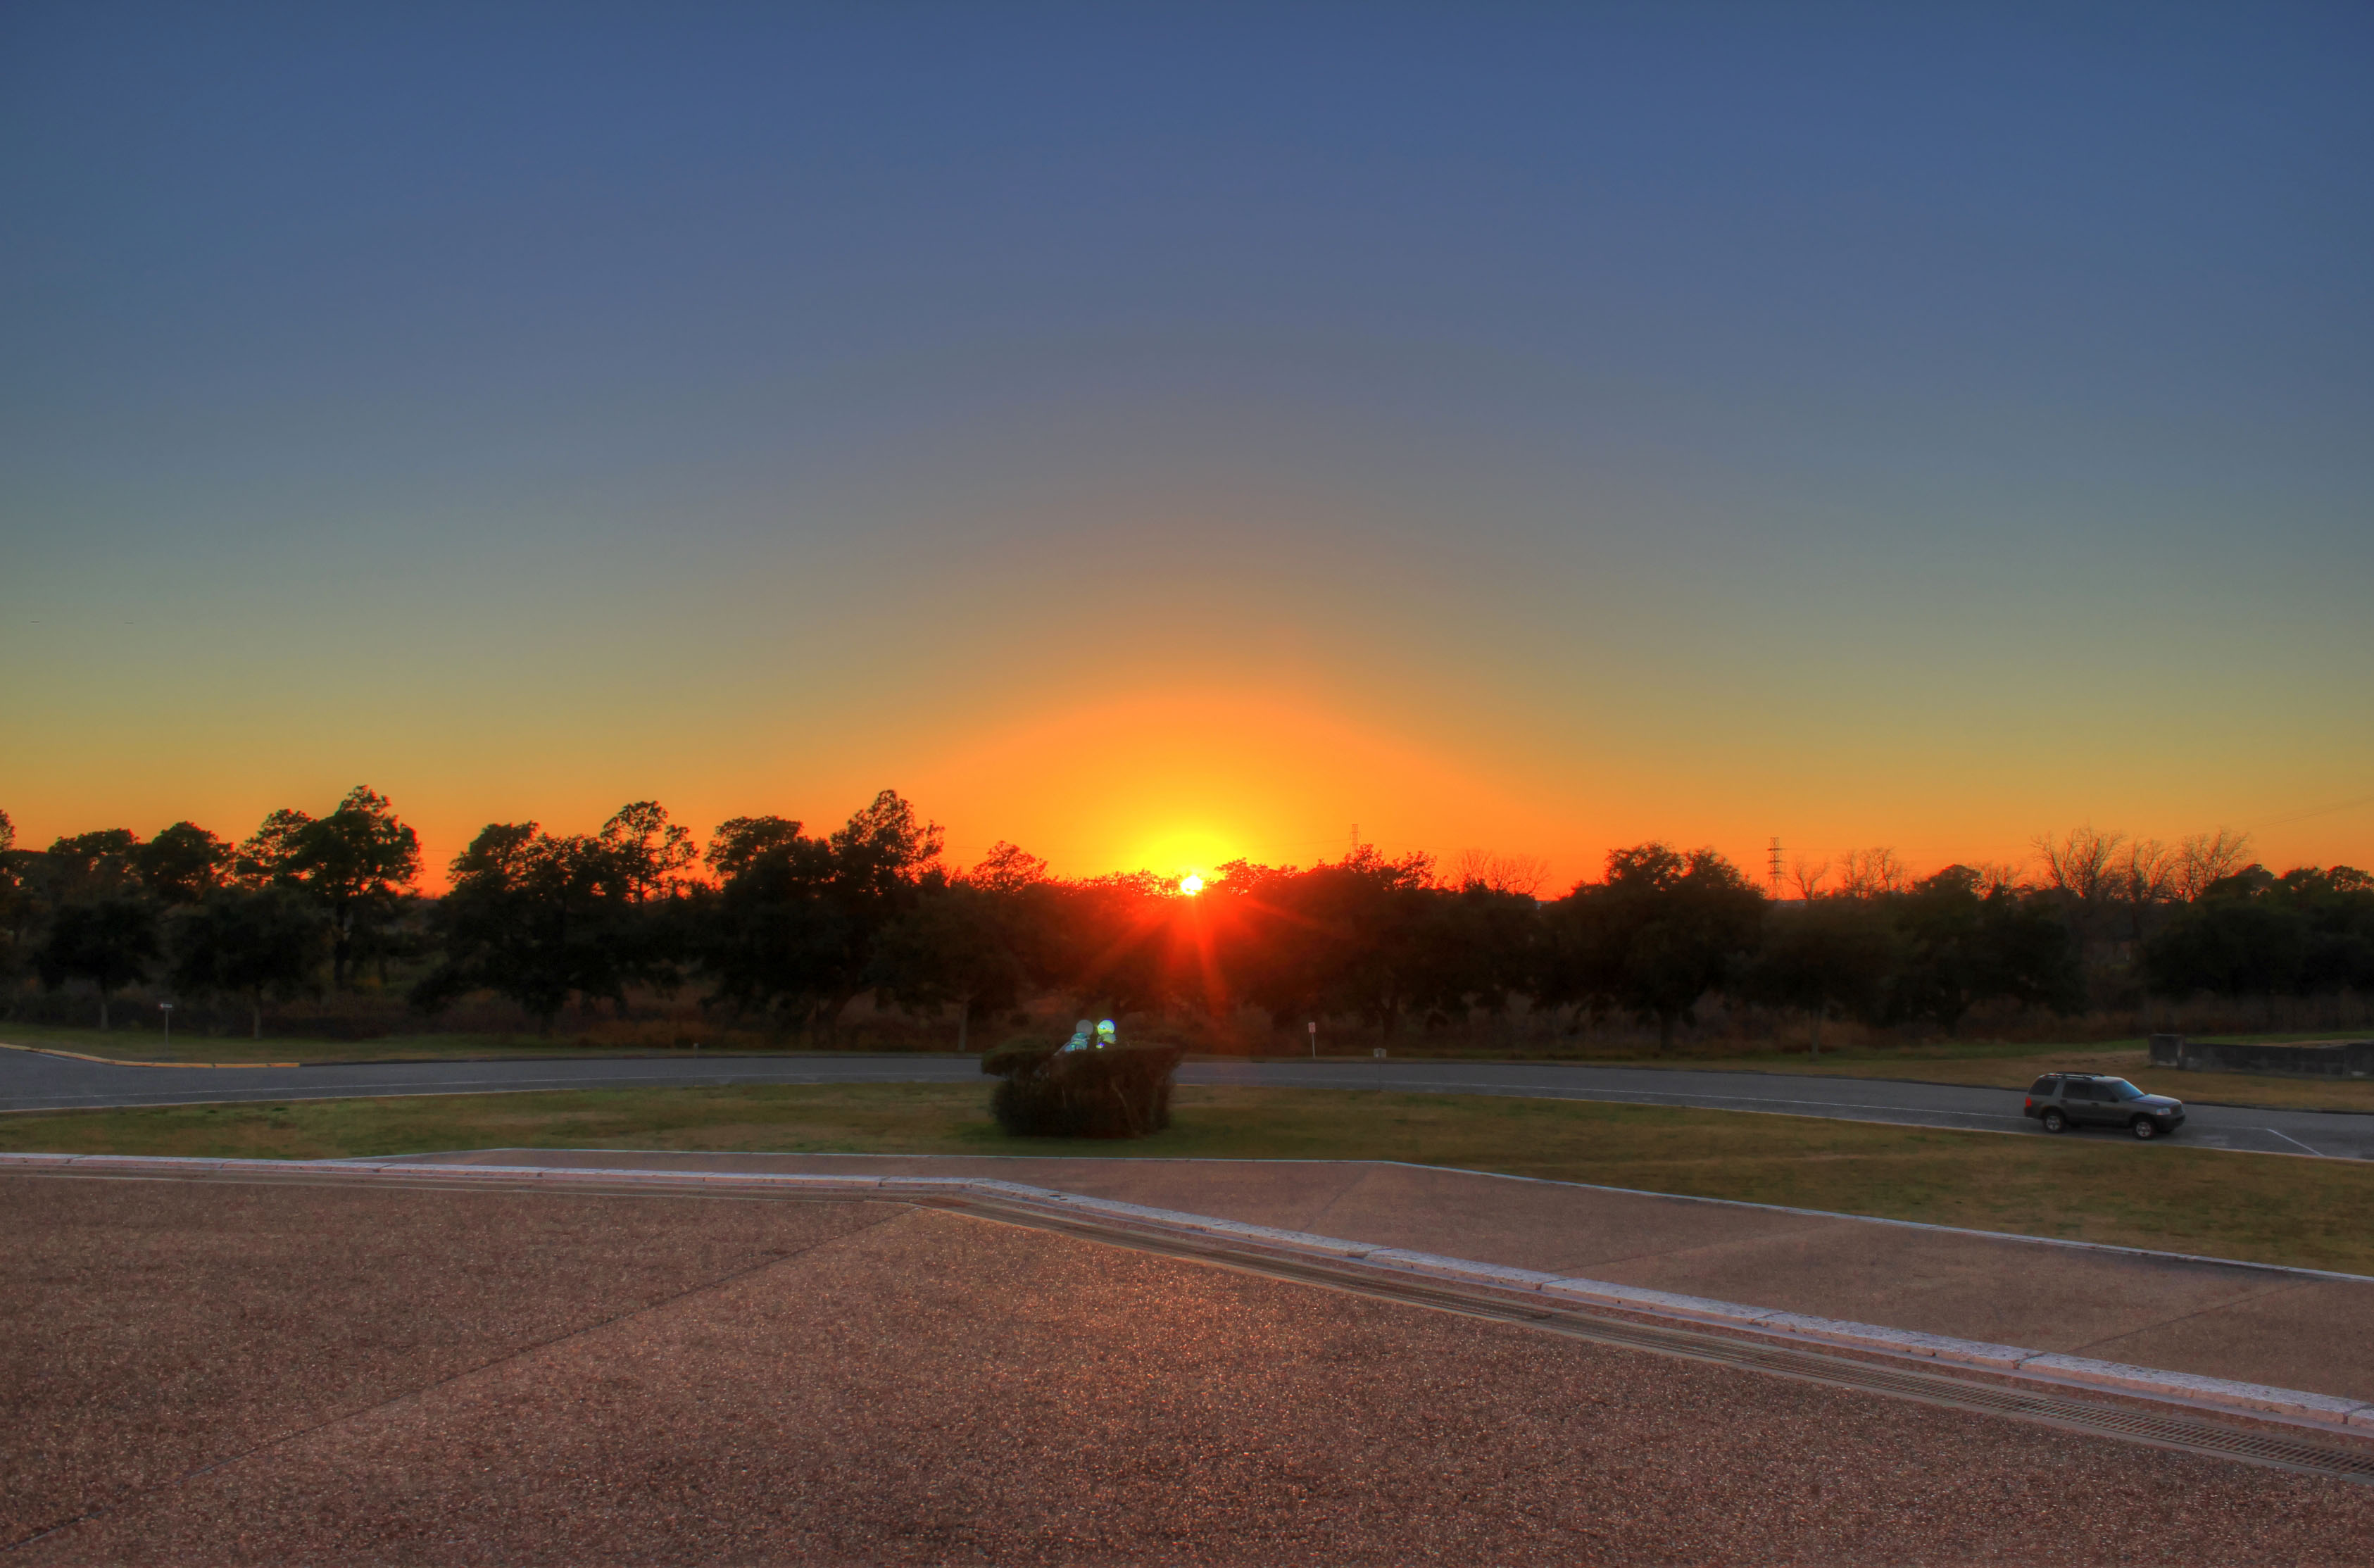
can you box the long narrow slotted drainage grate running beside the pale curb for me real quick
[954,1198,2374,1485]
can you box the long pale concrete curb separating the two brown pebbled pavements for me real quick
[18,1155,2374,1435]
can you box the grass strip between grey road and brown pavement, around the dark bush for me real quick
[0,1084,2374,1274]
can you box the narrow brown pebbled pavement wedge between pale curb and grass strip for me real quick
[380,1150,2374,1399]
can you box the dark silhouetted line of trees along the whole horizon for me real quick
[0,786,2374,1050]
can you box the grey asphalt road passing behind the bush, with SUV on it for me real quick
[0,1050,2374,1160]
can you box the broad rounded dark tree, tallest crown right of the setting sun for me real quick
[1543,843,1764,1053]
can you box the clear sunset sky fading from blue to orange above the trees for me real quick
[0,0,2374,882]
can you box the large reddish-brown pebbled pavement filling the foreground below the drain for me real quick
[0,1176,2374,1566]
